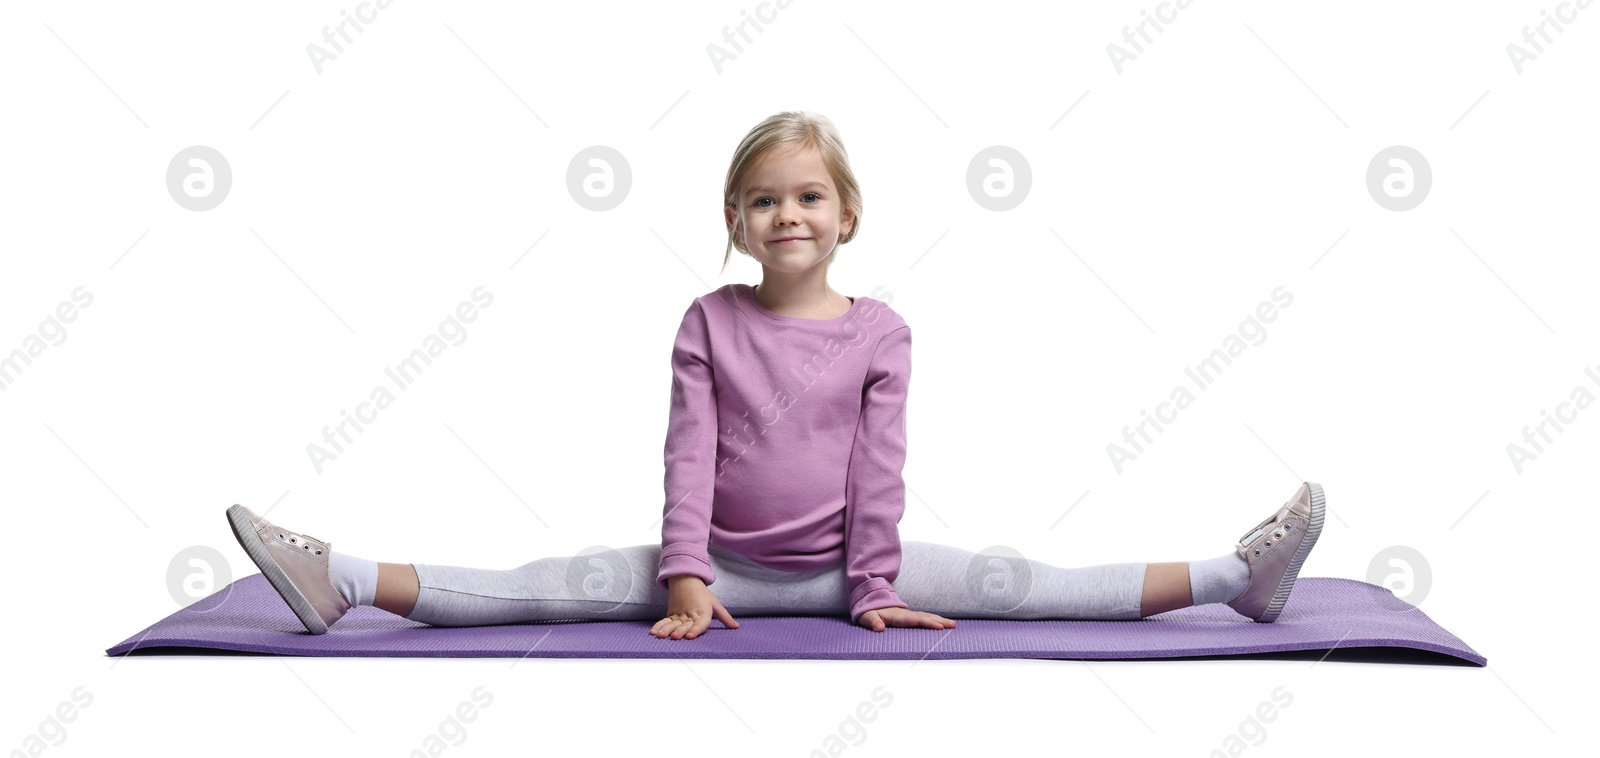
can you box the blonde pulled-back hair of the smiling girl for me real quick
[718,110,861,273]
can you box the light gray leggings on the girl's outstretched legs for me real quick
[406,541,1146,627]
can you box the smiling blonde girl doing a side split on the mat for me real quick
[227,112,1323,640]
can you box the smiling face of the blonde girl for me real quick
[725,147,854,273]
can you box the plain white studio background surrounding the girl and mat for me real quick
[0,0,1600,755]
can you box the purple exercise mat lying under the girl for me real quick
[106,574,1488,665]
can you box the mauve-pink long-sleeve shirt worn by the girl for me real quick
[656,285,910,622]
